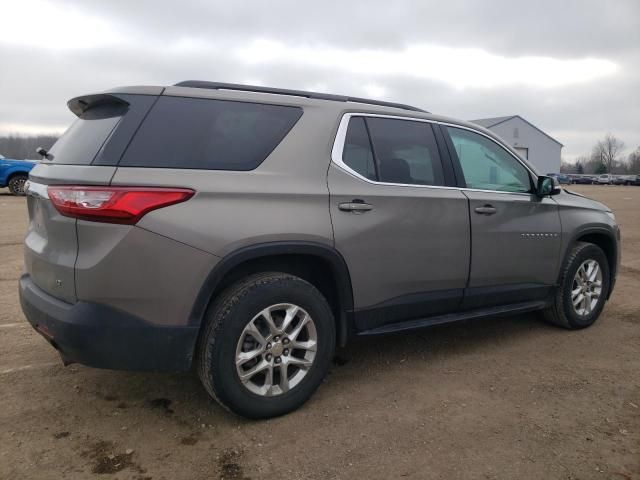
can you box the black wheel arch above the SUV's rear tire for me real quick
[189,241,354,346]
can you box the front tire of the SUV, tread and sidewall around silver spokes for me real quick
[542,242,610,330]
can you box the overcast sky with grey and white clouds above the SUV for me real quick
[0,0,640,160]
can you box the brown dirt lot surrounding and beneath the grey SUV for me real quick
[0,186,640,480]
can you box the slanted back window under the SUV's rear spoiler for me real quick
[49,104,127,165]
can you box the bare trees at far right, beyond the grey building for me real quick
[560,133,640,175]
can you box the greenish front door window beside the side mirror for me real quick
[447,127,532,193]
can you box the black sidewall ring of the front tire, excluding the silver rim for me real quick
[561,245,610,328]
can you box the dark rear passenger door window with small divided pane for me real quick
[342,117,444,185]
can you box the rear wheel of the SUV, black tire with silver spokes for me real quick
[196,272,336,419]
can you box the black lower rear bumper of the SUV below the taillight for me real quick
[20,274,198,372]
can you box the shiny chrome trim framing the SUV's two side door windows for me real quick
[331,112,538,197]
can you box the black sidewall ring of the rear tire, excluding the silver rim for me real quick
[207,277,335,418]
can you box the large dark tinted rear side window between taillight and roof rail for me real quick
[120,97,302,170]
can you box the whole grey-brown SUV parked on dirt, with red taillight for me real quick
[20,81,620,418]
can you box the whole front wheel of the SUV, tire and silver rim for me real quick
[543,242,610,329]
